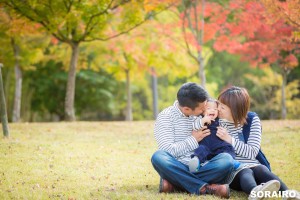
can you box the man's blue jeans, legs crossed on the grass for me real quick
[151,150,233,195]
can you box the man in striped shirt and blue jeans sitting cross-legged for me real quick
[151,83,233,198]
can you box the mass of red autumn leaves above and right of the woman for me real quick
[214,1,298,66]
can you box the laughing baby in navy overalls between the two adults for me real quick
[189,99,240,172]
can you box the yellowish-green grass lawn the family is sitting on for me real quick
[0,121,300,200]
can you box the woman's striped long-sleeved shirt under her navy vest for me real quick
[220,116,261,164]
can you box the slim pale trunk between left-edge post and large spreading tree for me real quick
[11,38,23,122]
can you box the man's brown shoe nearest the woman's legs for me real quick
[200,184,230,199]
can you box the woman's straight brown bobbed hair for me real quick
[218,86,250,127]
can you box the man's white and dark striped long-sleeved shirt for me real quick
[154,101,199,165]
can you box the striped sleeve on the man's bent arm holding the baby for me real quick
[154,113,199,157]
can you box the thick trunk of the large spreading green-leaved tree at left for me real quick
[65,43,79,121]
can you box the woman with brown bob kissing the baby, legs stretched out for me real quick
[217,86,296,199]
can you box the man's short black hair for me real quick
[177,83,208,110]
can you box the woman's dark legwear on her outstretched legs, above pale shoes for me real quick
[230,165,288,194]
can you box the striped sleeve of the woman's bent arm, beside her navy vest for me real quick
[232,116,261,160]
